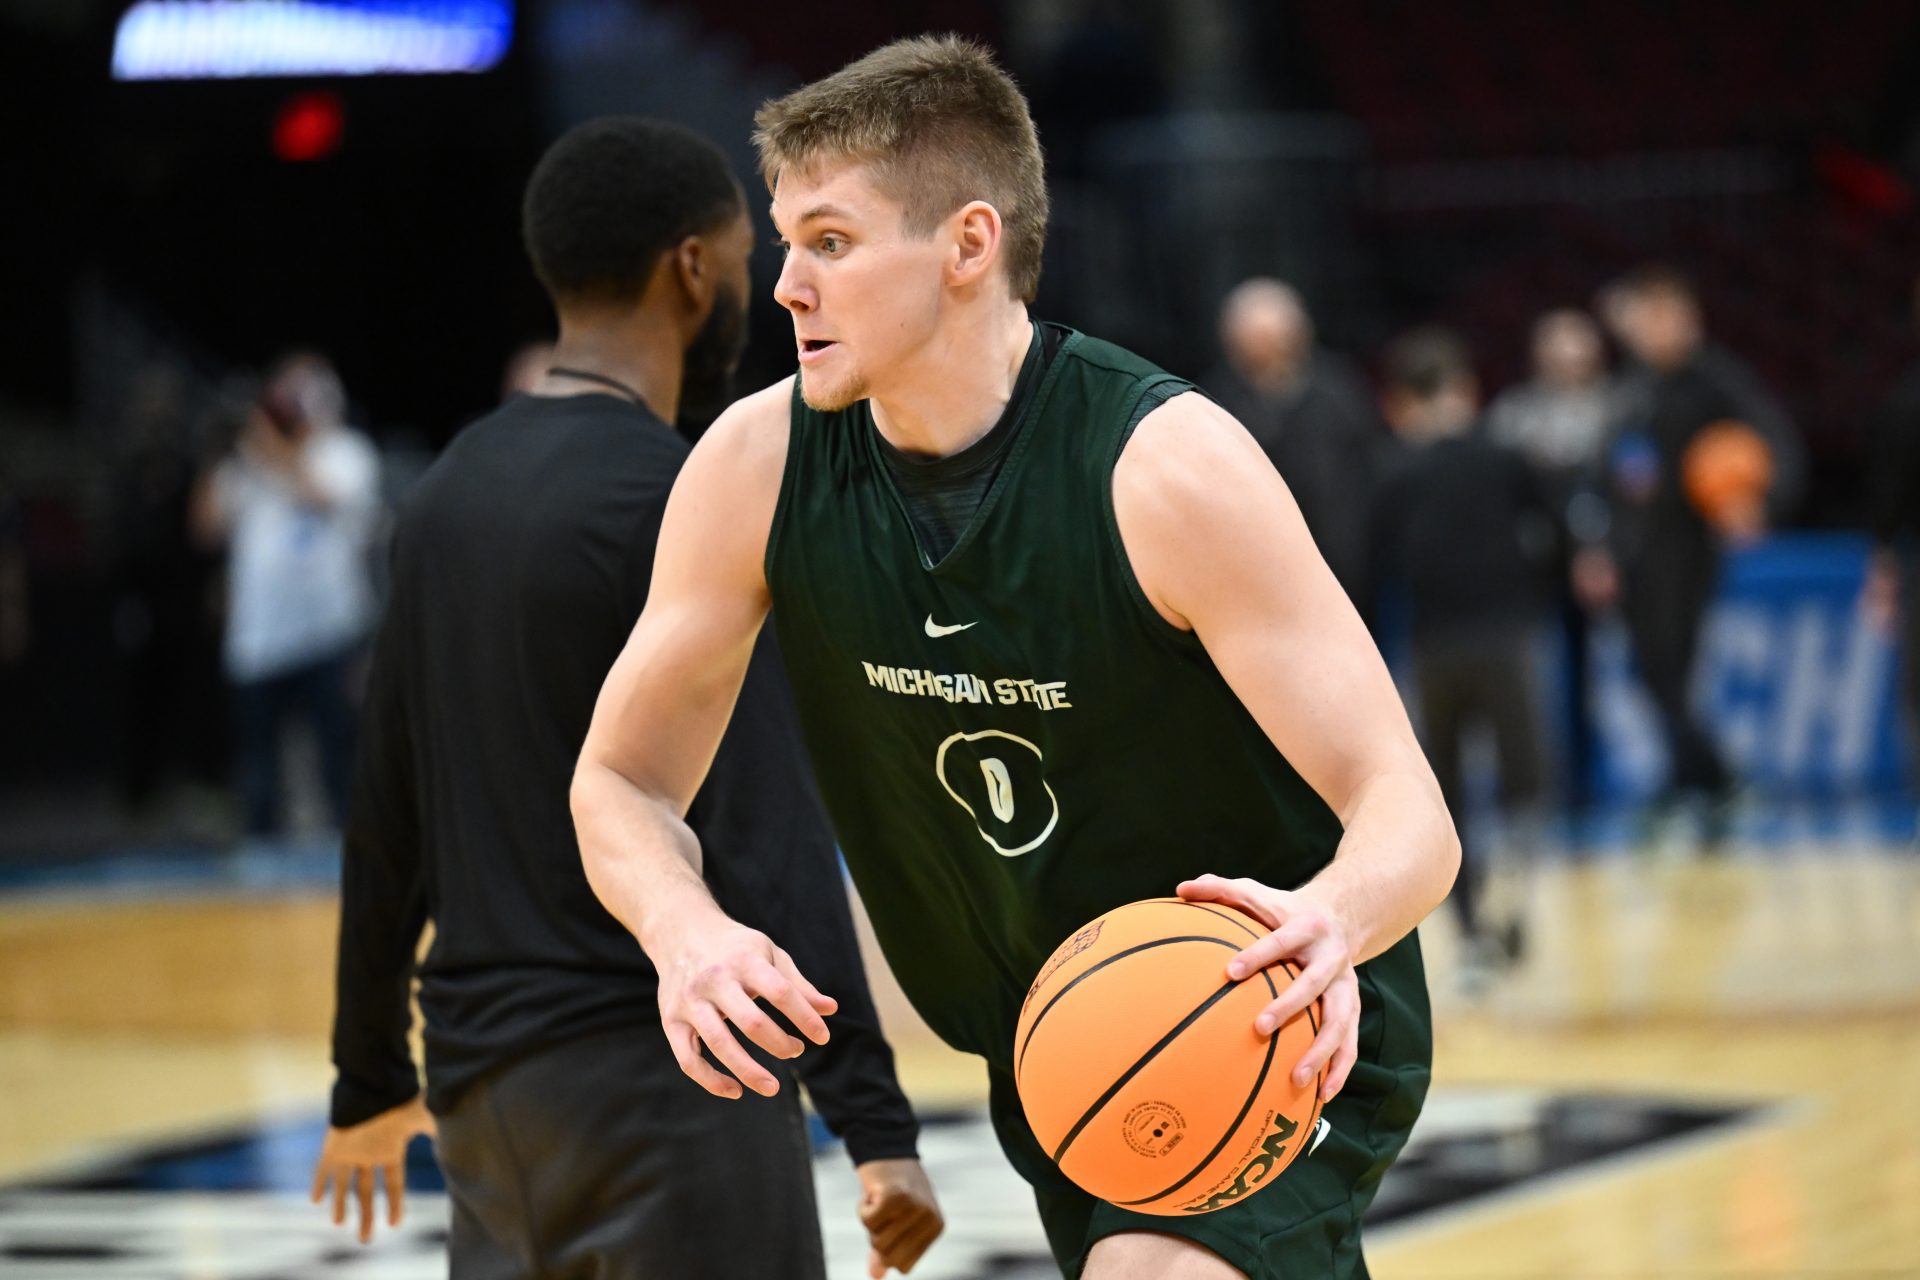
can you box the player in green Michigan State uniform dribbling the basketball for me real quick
[572,38,1457,1280]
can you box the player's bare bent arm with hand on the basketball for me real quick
[1114,393,1459,1098]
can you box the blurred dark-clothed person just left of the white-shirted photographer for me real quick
[113,363,219,810]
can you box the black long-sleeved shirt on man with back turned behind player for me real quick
[332,395,918,1163]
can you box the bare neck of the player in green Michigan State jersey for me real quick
[872,301,1033,457]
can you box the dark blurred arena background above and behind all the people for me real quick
[0,0,1920,802]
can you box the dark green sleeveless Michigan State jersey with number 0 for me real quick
[766,332,1430,1105]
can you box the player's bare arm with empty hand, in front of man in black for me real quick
[572,382,837,1098]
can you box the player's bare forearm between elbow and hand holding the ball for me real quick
[1300,771,1459,963]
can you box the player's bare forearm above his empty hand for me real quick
[572,760,718,954]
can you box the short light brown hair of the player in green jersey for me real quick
[753,35,1046,301]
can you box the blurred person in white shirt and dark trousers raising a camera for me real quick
[194,351,380,837]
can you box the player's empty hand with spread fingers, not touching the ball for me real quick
[649,906,839,1098]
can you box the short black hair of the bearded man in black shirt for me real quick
[520,115,747,303]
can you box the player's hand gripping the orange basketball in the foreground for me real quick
[1177,875,1359,1102]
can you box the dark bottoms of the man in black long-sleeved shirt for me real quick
[438,1027,826,1280]
